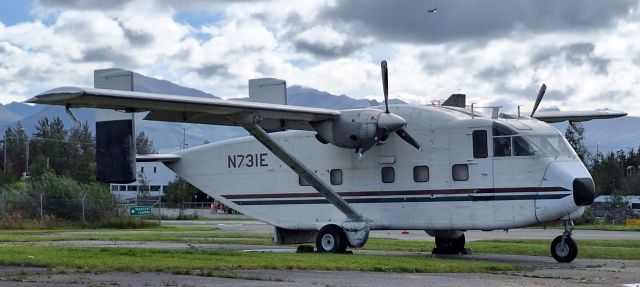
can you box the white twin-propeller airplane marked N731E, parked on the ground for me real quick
[27,61,626,262]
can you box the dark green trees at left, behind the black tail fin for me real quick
[0,117,200,207]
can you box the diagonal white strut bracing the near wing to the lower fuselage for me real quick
[234,116,364,221]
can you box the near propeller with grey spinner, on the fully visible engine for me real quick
[376,61,420,149]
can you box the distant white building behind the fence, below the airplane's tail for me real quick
[110,162,176,202]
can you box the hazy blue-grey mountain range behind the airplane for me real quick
[0,73,640,152]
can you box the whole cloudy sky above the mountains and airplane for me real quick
[0,0,640,116]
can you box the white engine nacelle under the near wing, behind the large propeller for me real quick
[312,109,384,148]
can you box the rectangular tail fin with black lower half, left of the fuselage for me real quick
[94,69,136,183]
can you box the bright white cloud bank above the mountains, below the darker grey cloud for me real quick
[0,0,640,118]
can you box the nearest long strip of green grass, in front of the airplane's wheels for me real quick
[0,246,519,273]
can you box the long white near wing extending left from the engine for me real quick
[27,87,340,130]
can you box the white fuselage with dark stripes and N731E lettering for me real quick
[168,106,590,230]
